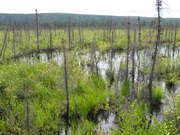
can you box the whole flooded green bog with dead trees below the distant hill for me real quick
[0,0,180,135]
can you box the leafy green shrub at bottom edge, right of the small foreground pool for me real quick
[112,101,164,135]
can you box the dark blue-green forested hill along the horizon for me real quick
[0,13,180,27]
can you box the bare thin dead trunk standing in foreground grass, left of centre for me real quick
[61,39,69,128]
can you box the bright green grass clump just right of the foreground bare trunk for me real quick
[70,77,107,119]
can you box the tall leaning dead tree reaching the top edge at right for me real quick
[148,0,162,114]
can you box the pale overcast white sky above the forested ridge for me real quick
[0,0,180,18]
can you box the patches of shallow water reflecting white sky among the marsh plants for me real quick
[15,46,180,134]
